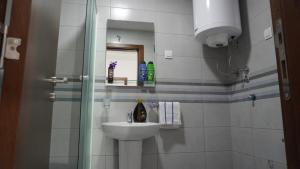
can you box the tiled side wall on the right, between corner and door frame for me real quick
[230,0,286,169]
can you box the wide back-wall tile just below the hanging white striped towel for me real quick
[156,128,204,153]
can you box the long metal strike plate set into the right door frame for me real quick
[275,19,291,100]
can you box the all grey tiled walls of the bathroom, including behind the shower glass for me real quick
[50,0,286,169]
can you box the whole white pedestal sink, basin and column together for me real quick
[102,122,159,169]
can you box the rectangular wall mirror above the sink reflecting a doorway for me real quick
[106,20,156,87]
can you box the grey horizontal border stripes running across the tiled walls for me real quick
[55,67,279,103]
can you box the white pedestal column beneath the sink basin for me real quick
[119,140,142,169]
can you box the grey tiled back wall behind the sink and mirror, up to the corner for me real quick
[92,0,232,169]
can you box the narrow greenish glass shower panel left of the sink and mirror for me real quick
[78,0,97,169]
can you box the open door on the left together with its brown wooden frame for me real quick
[0,0,61,169]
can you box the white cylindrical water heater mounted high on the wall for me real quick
[193,0,242,47]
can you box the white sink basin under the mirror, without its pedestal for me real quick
[102,122,159,140]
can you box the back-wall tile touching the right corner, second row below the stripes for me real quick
[205,127,231,151]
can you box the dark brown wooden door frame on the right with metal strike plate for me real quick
[270,0,300,169]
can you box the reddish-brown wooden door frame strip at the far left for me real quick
[0,0,31,169]
